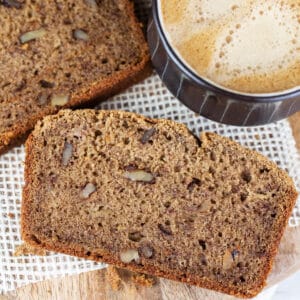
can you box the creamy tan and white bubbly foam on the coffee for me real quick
[161,0,300,94]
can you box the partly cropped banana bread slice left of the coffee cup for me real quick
[0,0,150,152]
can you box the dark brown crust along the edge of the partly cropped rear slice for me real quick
[0,0,152,154]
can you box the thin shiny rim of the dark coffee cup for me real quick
[152,0,300,103]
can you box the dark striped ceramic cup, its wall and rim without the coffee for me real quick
[147,0,300,126]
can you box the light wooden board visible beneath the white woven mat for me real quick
[0,113,300,300]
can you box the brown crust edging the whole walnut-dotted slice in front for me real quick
[21,111,297,298]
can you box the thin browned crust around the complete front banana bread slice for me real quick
[21,111,298,298]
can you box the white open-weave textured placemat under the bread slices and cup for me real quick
[0,0,300,293]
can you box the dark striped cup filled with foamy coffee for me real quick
[147,0,300,126]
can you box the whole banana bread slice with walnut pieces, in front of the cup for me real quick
[22,110,297,297]
